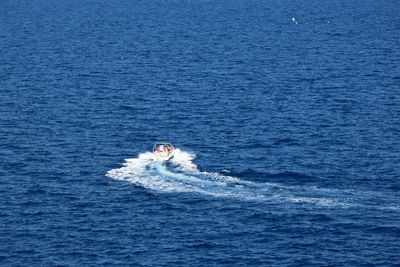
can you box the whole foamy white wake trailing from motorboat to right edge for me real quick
[106,149,400,210]
